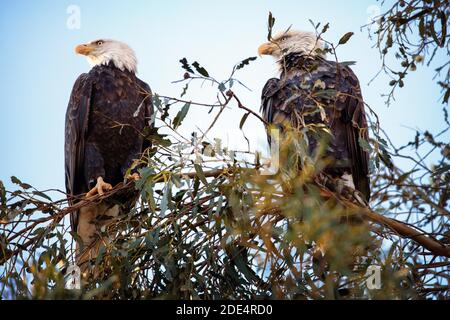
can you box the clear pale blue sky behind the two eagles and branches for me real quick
[0,0,447,189]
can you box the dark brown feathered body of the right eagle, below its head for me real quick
[261,61,370,200]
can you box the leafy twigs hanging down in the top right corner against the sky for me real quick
[367,0,450,105]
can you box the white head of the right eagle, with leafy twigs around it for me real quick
[258,30,324,60]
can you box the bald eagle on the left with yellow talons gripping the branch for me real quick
[65,39,153,269]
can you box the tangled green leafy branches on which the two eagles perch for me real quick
[0,5,450,299]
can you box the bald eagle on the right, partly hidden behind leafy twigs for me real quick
[258,30,370,201]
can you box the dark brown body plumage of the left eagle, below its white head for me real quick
[65,64,153,264]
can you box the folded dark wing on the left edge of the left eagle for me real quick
[64,73,92,232]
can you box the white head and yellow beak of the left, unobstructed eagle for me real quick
[75,39,137,73]
